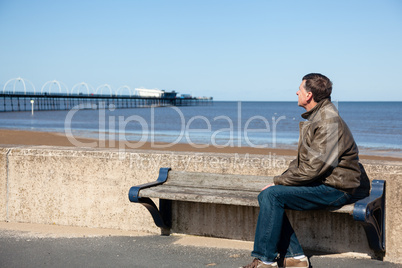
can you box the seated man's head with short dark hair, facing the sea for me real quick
[296,73,332,111]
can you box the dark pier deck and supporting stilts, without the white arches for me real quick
[0,92,212,112]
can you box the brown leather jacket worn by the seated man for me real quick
[274,99,360,193]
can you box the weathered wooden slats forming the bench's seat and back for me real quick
[139,171,354,215]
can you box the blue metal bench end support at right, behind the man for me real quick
[353,180,385,256]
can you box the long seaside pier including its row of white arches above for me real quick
[0,77,212,112]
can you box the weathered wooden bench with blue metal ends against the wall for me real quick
[129,168,385,255]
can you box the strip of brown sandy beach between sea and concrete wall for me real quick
[0,129,402,161]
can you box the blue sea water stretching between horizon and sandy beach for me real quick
[0,101,402,157]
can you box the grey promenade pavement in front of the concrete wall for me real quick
[0,223,402,268]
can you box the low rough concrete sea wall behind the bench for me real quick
[0,147,402,263]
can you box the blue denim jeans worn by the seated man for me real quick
[251,184,351,261]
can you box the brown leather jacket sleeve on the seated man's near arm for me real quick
[274,120,342,186]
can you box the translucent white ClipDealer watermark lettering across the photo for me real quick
[64,102,286,157]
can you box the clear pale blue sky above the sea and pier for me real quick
[0,0,402,101]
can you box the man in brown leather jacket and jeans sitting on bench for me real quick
[244,73,360,268]
